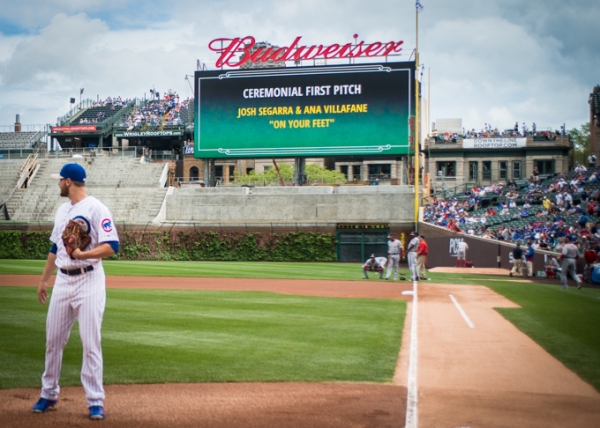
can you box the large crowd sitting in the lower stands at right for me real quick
[424,165,600,254]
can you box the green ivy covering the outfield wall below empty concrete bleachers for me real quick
[0,228,336,262]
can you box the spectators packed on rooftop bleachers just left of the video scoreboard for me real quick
[119,93,191,130]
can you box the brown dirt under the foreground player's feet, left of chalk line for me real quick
[0,382,406,428]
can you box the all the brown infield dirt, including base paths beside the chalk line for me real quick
[0,276,600,428]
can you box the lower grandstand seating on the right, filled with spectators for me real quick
[424,164,600,250]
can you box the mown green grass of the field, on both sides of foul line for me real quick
[0,260,600,391]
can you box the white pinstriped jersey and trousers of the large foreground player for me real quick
[41,196,119,407]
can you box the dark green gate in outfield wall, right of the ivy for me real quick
[336,223,390,263]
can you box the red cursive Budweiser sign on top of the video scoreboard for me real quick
[208,34,404,68]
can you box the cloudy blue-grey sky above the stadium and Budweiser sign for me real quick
[0,0,600,134]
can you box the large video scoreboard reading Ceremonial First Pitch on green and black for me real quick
[194,62,414,159]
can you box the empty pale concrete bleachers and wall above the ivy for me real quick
[1,154,414,224]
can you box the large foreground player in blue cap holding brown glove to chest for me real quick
[32,163,119,419]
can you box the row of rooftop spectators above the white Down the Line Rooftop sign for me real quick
[432,122,565,143]
